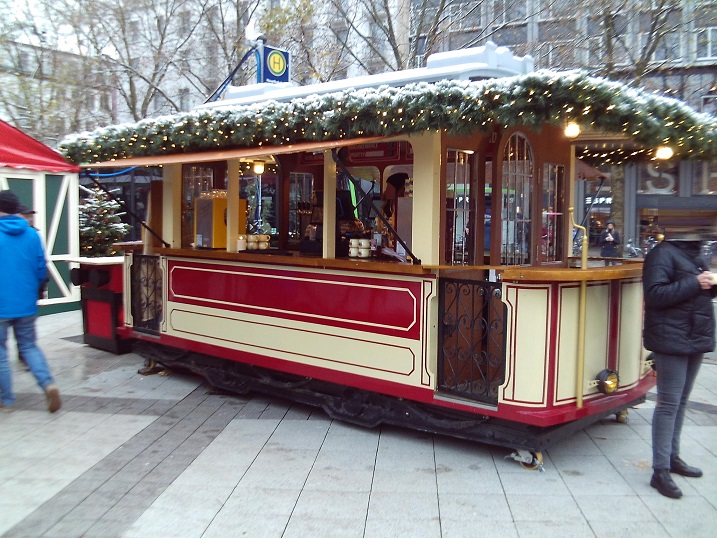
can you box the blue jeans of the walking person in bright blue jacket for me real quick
[0,316,54,407]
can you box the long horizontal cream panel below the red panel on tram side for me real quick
[167,302,421,384]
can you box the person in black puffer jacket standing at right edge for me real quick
[642,235,717,499]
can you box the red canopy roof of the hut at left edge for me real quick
[0,120,80,172]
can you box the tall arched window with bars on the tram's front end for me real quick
[500,133,533,265]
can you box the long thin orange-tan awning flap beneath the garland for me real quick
[82,136,390,168]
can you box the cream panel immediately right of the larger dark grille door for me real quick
[500,284,552,407]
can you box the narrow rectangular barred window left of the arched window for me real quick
[444,148,476,265]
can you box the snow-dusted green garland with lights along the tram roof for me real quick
[60,71,717,164]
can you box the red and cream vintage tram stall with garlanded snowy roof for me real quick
[63,46,715,467]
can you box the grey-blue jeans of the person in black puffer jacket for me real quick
[652,353,704,469]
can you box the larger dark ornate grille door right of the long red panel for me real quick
[438,278,507,405]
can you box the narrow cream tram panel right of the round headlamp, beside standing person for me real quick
[617,281,645,387]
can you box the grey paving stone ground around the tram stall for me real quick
[0,312,717,538]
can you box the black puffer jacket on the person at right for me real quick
[642,241,717,355]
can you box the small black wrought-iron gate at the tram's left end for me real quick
[132,254,162,334]
